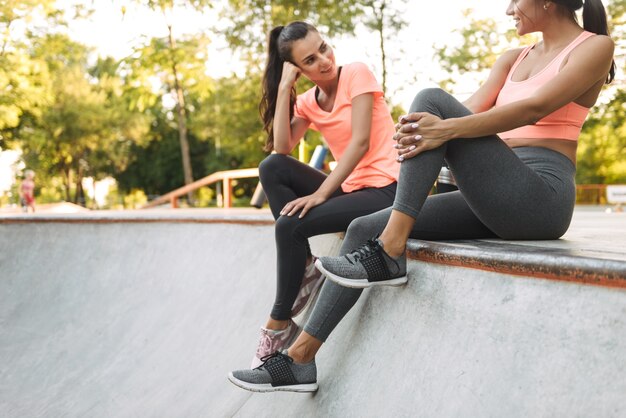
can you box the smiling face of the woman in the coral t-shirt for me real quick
[291,31,337,83]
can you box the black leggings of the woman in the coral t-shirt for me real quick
[259,154,396,320]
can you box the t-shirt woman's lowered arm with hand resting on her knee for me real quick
[280,93,374,218]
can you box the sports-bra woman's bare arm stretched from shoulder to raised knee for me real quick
[394,35,614,159]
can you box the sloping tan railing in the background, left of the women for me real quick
[142,168,259,209]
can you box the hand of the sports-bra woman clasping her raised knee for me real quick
[393,112,452,162]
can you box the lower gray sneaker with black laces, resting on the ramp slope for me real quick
[228,351,317,392]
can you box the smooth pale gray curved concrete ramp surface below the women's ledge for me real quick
[0,212,626,417]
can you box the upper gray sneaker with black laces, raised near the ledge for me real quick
[315,238,407,289]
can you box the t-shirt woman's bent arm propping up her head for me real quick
[272,61,310,154]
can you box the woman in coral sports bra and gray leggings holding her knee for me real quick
[227,0,614,391]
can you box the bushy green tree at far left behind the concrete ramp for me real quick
[12,34,148,203]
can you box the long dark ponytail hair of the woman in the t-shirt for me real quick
[259,21,317,151]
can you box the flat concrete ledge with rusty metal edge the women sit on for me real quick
[0,208,626,288]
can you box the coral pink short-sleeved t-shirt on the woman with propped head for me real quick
[294,62,400,193]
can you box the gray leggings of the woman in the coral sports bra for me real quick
[304,89,576,341]
